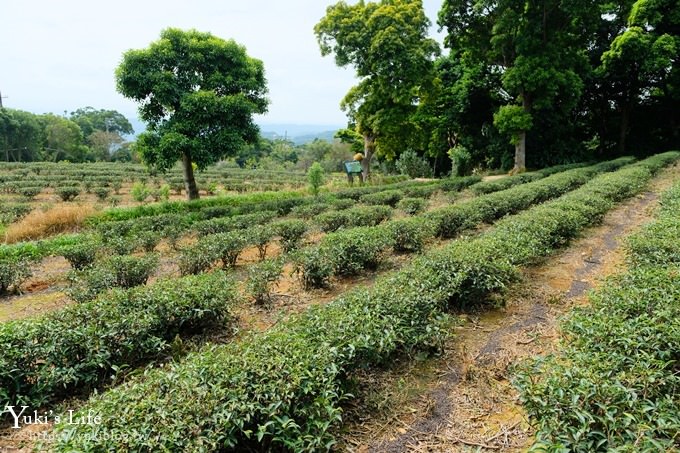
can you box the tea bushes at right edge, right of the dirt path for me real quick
[516,172,680,452]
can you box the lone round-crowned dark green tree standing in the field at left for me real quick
[116,28,268,199]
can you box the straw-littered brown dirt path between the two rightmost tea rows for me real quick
[346,165,680,453]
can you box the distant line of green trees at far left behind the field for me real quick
[0,107,134,162]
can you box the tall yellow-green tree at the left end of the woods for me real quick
[314,0,439,179]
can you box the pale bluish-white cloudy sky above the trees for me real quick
[0,0,442,131]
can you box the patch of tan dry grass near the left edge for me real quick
[5,205,95,244]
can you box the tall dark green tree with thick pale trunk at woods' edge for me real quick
[440,0,599,172]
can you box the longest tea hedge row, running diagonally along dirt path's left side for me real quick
[51,154,679,451]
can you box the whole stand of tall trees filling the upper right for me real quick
[315,0,680,177]
